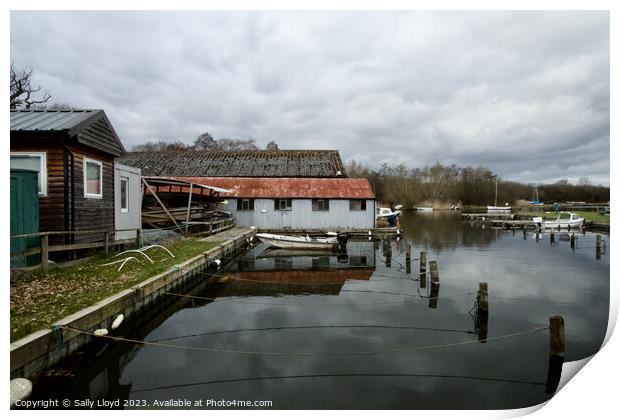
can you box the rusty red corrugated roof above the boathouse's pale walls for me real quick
[174,177,375,199]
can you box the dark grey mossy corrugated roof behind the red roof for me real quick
[122,150,346,177]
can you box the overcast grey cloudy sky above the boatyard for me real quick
[11,11,610,185]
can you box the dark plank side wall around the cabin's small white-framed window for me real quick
[70,146,114,242]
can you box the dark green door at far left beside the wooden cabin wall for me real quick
[11,169,41,267]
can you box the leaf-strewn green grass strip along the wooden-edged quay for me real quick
[11,240,218,342]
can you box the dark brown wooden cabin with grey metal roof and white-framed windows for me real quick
[11,109,141,244]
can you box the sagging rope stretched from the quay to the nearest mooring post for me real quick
[65,326,549,357]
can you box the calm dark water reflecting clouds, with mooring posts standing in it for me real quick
[35,213,610,409]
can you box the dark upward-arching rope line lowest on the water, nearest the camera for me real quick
[131,372,547,393]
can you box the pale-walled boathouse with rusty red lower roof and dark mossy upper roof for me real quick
[122,150,376,230]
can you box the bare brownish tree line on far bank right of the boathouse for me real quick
[346,160,609,207]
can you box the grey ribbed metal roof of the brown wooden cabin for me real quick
[11,109,103,131]
